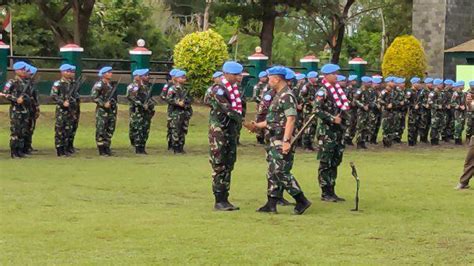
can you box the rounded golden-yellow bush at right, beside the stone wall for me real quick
[382,35,426,78]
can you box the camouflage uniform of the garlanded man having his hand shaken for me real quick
[208,80,242,200]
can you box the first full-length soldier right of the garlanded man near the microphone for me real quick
[354,76,372,149]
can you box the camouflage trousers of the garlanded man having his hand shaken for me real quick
[208,122,237,194]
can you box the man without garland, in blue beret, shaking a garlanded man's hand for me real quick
[252,67,311,215]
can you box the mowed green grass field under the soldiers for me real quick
[0,101,474,265]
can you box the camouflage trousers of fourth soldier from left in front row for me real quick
[129,110,154,147]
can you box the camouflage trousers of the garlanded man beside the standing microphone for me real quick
[317,125,345,187]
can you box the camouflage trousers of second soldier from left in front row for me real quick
[54,106,74,148]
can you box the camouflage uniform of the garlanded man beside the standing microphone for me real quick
[314,86,348,201]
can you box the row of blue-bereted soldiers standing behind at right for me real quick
[253,71,474,151]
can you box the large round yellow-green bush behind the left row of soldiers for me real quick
[174,30,229,97]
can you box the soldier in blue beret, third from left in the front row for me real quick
[91,66,118,156]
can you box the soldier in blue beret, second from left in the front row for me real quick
[51,64,77,157]
